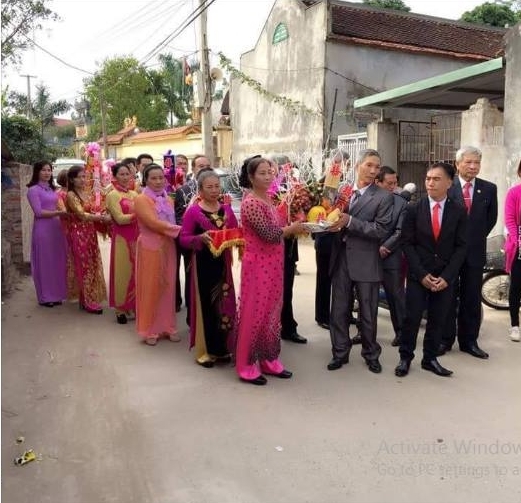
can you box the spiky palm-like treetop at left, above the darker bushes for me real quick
[7,84,71,135]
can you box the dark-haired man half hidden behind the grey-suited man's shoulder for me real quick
[376,166,407,346]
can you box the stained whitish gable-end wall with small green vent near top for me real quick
[230,0,327,163]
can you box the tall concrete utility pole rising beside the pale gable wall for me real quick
[198,0,214,166]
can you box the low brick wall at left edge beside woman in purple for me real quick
[2,162,33,293]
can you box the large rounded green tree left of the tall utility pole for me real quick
[85,57,168,139]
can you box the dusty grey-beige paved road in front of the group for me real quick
[2,237,521,503]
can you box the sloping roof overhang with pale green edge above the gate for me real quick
[354,58,505,110]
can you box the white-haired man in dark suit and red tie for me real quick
[439,147,498,359]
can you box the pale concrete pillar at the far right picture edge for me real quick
[504,23,521,191]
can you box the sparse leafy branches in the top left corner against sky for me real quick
[2,0,59,66]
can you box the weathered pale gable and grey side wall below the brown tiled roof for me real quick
[230,0,480,163]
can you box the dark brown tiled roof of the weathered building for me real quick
[329,2,506,60]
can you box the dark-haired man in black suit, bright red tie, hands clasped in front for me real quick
[394,162,467,377]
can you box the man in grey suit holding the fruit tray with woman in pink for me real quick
[327,149,393,373]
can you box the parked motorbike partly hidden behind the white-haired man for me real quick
[481,236,510,310]
